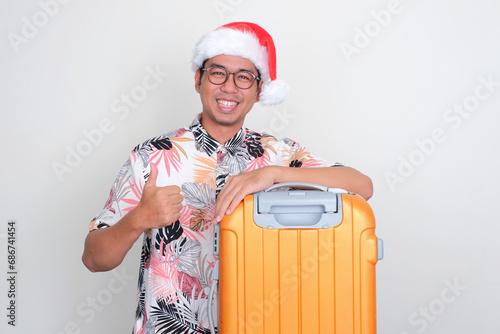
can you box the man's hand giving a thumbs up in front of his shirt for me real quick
[134,163,184,230]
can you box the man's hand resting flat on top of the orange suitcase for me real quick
[214,166,279,223]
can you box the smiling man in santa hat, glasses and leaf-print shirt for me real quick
[82,22,372,333]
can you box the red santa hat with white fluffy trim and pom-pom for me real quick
[192,22,288,106]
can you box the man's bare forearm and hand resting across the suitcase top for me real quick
[214,166,373,222]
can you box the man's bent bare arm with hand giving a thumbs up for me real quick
[82,164,183,272]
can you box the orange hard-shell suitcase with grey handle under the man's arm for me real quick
[209,183,383,334]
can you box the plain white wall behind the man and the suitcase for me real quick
[0,0,500,334]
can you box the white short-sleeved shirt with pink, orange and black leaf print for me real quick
[90,115,338,334]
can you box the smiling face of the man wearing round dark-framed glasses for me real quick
[195,55,262,143]
